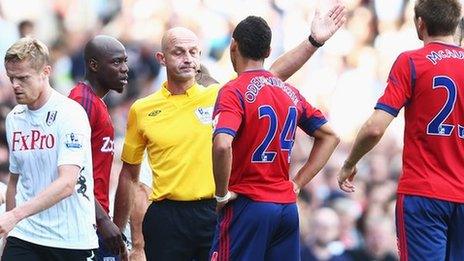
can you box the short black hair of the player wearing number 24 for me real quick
[232,16,272,60]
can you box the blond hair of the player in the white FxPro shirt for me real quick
[5,37,49,71]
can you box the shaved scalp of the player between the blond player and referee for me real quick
[84,35,125,63]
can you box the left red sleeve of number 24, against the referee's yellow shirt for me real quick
[213,85,245,137]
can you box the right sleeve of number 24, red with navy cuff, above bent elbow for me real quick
[298,91,327,135]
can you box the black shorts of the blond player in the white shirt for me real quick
[2,237,97,261]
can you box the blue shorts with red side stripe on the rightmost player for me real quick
[396,194,464,261]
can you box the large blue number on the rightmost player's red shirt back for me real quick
[427,76,464,138]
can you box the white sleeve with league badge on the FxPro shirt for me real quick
[56,104,91,167]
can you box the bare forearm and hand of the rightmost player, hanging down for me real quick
[338,110,394,192]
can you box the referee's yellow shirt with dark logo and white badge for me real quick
[121,83,219,201]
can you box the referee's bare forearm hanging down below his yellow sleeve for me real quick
[113,162,140,231]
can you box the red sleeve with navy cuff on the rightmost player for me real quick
[375,53,416,117]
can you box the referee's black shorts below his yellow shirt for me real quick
[142,199,217,261]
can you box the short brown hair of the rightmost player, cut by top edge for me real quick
[414,0,461,36]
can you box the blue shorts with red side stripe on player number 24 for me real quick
[210,196,300,261]
